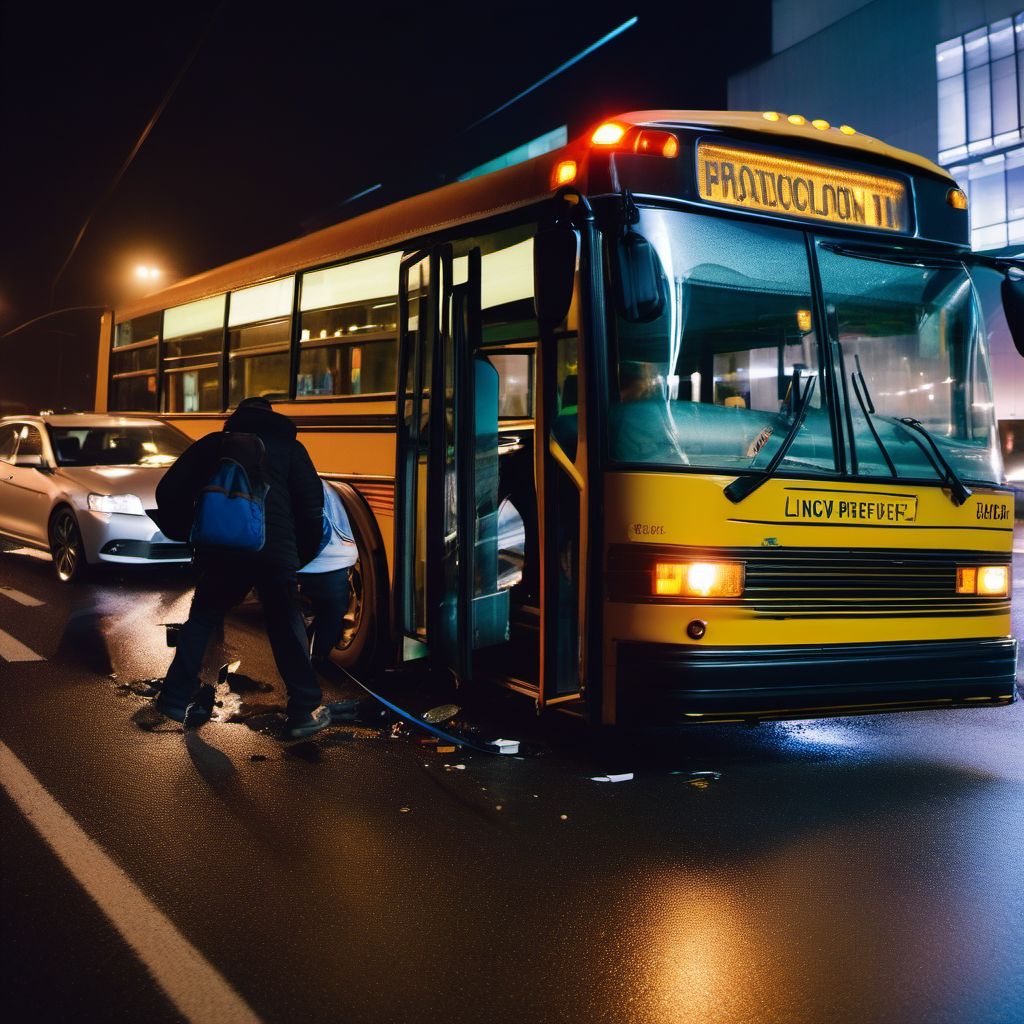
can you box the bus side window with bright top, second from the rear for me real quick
[163,295,227,413]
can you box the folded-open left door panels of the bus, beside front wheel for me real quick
[394,246,509,680]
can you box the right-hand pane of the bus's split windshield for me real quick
[818,242,999,483]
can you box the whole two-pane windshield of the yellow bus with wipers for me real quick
[607,209,999,483]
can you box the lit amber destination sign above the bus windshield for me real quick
[697,142,910,231]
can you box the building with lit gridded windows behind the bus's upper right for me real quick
[728,0,1024,428]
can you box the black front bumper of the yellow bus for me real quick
[616,637,1017,724]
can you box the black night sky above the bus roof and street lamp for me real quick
[0,0,771,390]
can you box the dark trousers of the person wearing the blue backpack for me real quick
[160,559,323,718]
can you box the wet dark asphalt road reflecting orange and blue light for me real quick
[0,531,1024,1024]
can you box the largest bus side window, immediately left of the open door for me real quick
[295,253,401,398]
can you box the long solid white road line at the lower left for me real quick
[0,742,259,1024]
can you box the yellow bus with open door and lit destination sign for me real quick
[96,111,1022,724]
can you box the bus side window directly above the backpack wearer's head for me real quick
[227,276,295,407]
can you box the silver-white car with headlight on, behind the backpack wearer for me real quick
[0,413,191,583]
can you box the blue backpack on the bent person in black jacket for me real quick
[189,432,270,552]
